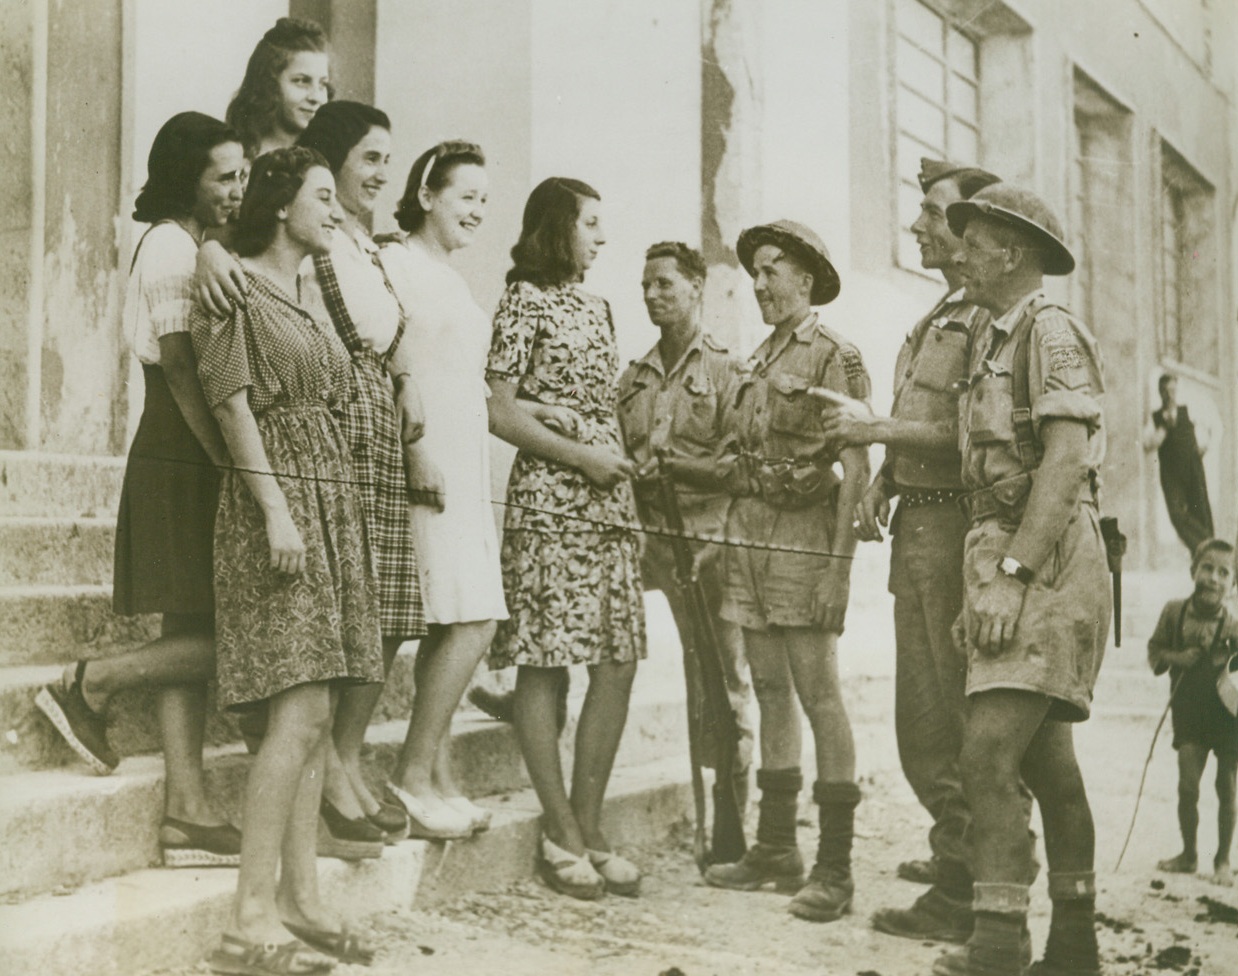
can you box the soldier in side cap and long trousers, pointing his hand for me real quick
[822,159,998,943]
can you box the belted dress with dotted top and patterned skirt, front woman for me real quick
[189,270,384,708]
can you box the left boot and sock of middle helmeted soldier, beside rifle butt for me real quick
[704,767,803,892]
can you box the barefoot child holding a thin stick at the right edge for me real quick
[1148,539,1238,887]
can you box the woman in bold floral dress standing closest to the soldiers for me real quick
[487,177,645,898]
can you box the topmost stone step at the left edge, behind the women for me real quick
[0,451,125,518]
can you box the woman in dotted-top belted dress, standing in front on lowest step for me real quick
[189,147,383,976]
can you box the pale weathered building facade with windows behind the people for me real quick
[0,0,1238,566]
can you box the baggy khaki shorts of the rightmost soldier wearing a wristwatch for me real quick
[954,505,1113,722]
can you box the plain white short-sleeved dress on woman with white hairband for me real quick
[380,242,508,624]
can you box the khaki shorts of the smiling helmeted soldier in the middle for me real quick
[722,498,834,630]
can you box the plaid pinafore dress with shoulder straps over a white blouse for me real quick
[313,244,426,640]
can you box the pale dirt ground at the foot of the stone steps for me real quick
[337,638,1238,976]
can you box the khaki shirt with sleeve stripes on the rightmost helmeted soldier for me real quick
[958,291,1104,490]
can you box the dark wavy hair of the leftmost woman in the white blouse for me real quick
[134,111,240,224]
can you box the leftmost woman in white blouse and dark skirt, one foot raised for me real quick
[36,111,245,867]
